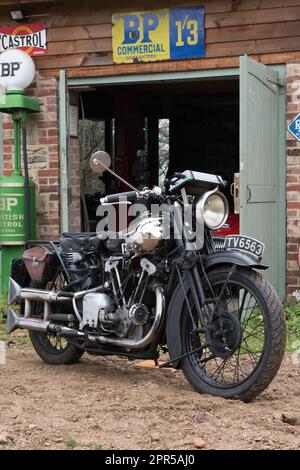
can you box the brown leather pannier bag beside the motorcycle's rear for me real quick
[23,246,54,282]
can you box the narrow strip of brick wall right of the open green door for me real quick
[286,63,300,297]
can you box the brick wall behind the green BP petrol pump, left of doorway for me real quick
[3,73,59,239]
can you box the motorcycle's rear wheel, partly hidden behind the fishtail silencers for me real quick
[29,275,84,365]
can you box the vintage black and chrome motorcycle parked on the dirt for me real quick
[7,152,285,401]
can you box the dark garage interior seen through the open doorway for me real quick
[80,79,239,231]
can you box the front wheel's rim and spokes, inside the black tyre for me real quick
[184,280,267,388]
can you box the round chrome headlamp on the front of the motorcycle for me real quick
[196,191,229,230]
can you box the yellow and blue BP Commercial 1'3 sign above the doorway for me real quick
[112,6,205,64]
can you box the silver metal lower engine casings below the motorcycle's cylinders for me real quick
[80,292,149,337]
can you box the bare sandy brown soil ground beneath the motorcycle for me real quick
[0,346,300,450]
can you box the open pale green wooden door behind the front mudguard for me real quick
[240,56,285,295]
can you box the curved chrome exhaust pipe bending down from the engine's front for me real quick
[88,286,165,349]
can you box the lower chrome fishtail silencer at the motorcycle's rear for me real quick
[6,307,84,338]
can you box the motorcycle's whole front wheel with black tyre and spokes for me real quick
[181,268,285,401]
